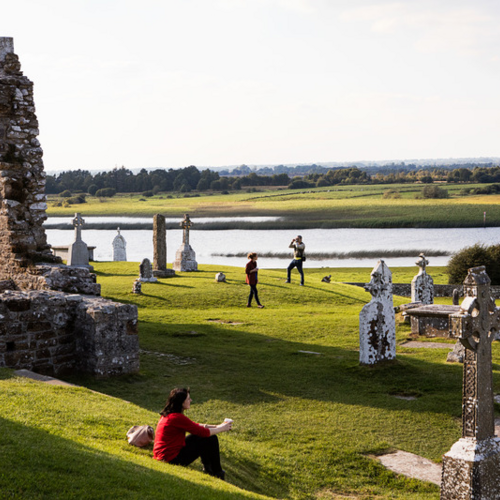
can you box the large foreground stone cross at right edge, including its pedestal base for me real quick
[441,266,500,500]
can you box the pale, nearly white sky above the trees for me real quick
[0,0,500,171]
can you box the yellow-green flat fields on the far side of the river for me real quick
[47,184,500,229]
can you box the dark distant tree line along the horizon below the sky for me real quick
[46,165,500,197]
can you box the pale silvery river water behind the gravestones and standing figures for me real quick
[46,217,500,269]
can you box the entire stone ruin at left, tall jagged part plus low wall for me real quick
[0,37,139,377]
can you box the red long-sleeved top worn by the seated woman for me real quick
[153,413,210,462]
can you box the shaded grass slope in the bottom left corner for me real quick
[0,418,270,500]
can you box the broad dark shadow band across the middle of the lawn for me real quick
[77,322,462,417]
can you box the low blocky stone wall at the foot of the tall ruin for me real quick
[0,290,139,377]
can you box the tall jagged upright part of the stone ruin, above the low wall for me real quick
[0,37,57,287]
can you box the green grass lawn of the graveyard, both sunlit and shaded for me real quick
[0,260,500,500]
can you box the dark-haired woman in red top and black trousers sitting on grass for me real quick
[153,388,233,479]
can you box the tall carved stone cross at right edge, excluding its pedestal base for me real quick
[450,266,500,440]
